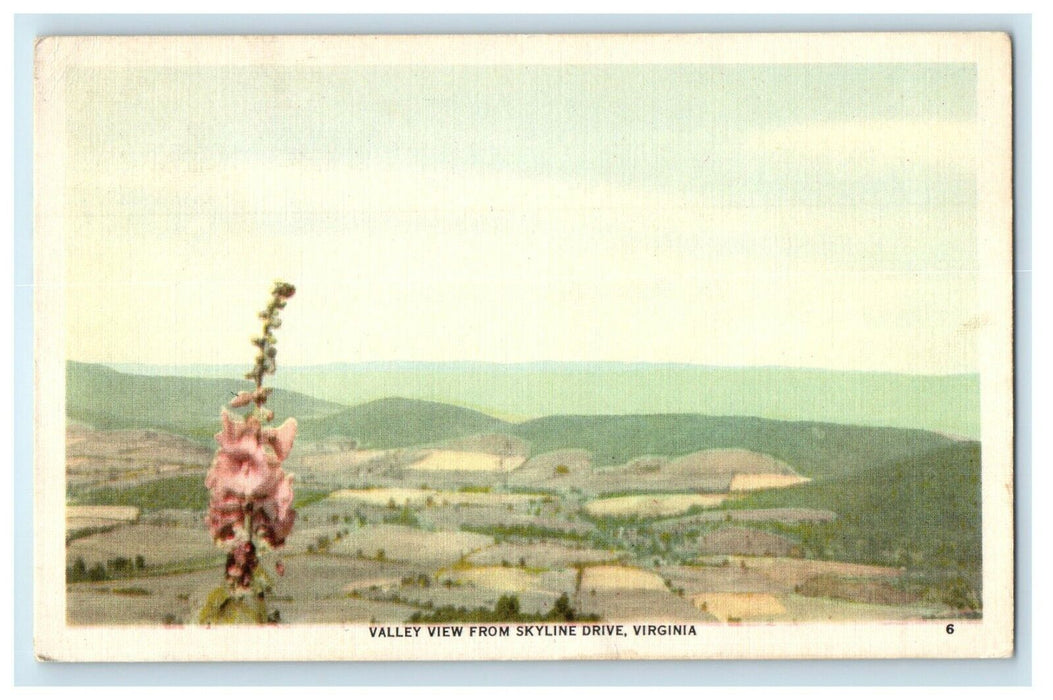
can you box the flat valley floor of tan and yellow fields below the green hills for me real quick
[66,428,962,625]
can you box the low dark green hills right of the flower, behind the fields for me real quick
[301,399,954,478]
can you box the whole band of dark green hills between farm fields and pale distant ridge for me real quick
[66,362,955,478]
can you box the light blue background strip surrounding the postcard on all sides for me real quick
[13,15,1032,685]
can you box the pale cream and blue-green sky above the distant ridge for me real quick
[65,63,978,373]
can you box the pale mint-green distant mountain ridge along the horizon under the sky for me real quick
[106,361,979,438]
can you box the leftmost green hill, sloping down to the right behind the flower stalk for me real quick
[66,362,345,443]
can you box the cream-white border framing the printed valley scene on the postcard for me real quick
[33,33,1014,661]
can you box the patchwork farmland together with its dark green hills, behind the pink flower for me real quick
[66,360,982,625]
